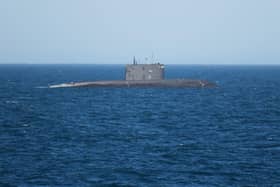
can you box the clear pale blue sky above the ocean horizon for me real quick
[0,0,280,64]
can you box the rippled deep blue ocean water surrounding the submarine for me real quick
[0,65,280,186]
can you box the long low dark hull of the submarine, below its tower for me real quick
[49,79,216,88]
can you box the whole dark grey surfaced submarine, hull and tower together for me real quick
[49,57,216,88]
